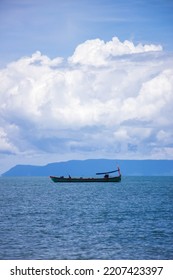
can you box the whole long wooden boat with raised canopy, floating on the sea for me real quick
[50,167,121,183]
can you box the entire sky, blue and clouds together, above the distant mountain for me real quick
[0,0,173,174]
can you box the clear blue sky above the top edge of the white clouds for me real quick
[0,0,173,63]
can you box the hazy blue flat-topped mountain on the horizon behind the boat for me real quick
[2,159,173,177]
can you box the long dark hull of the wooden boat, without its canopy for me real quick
[50,175,121,183]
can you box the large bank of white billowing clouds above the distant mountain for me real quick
[0,37,173,168]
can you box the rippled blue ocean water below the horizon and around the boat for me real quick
[0,177,173,260]
